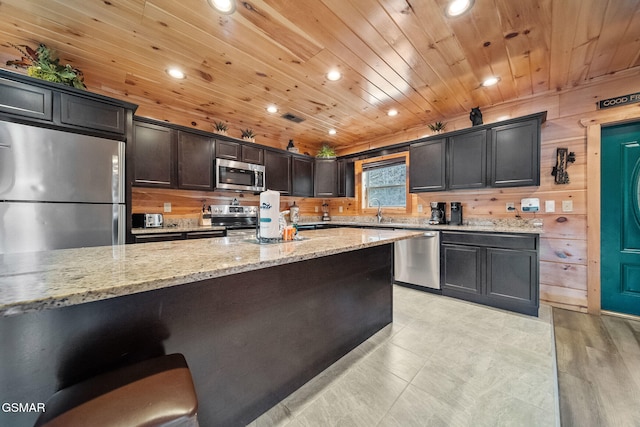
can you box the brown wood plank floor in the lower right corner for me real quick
[553,308,640,427]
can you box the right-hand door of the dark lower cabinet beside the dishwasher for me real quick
[487,248,538,309]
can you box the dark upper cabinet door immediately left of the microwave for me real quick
[178,131,213,191]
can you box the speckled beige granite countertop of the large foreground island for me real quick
[0,228,420,316]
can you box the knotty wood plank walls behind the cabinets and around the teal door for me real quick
[133,71,640,311]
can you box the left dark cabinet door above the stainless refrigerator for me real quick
[0,78,53,121]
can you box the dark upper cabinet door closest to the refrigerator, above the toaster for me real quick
[133,122,176,188]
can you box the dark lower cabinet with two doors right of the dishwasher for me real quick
[440,231,540,316]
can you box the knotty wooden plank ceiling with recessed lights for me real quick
[0,0,640,154]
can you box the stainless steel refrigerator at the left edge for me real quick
[0,121,126,254]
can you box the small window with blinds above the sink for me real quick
[362,158,407,208]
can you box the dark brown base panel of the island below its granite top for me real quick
[0,244,393,427]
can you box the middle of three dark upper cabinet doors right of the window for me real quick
[448,129,487,190]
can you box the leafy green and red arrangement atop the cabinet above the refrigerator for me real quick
[7,43,87,89]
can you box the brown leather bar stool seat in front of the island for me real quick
[35,354,198,427]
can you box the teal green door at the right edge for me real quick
[600,123,640,316]
